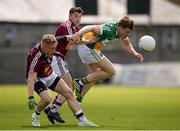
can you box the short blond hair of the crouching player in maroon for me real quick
[41,34,57,45]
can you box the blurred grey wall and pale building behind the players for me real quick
[0,0,180,87]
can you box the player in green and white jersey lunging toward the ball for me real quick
[72,16,143,102]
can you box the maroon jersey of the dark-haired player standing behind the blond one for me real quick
[55,20,79,59]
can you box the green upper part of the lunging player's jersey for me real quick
[99,22,118,41]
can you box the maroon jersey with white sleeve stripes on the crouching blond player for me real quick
[26,42,52,78]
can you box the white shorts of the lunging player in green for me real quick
[77,45,105,64]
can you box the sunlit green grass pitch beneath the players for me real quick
[0,85,180,130]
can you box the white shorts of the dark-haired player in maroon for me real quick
[51,56,69,76]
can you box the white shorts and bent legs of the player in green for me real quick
[72,45,115,102]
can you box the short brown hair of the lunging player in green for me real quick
[118,16,134,30]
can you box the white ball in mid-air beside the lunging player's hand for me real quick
[139,35,156,52]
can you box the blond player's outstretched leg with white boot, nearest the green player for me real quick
[49,78,97,126]
